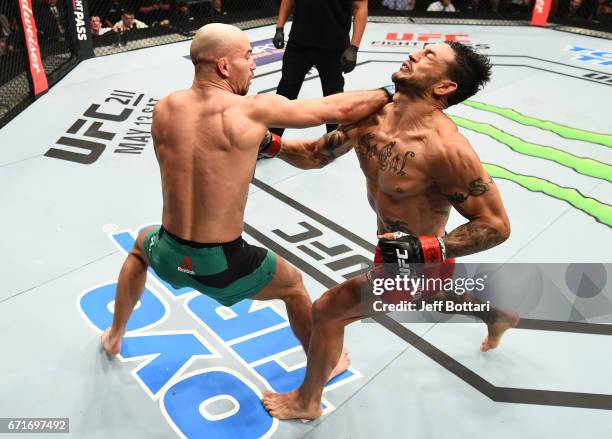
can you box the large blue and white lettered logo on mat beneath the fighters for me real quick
[77,228,360,438]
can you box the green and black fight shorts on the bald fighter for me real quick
[144,226,276,306]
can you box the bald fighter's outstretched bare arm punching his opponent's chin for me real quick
[251,88,390,128]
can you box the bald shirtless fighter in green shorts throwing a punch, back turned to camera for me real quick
[102,23,390,373]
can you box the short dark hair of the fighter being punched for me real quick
[446,41,491,107]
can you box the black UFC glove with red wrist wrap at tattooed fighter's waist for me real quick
[378,232,446,275]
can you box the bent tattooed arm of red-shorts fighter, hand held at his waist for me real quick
[432,132,510,258]
